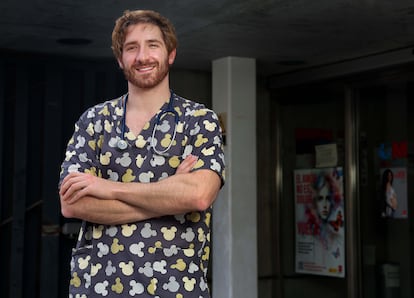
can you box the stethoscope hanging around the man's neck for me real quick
[116,91,179,155]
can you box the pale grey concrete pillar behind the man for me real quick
[212,57,258,298]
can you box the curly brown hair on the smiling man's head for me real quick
[111,10,178,59]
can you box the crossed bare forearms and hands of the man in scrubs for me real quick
[59,156,221,224]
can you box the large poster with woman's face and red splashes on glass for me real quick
[294,167,345,277]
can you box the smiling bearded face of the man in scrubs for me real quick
[118,24,175,89]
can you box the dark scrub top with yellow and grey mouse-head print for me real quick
[60,95,225,298]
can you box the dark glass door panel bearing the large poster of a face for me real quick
[273,83,347,298]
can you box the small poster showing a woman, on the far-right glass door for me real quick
[379,167,408,218]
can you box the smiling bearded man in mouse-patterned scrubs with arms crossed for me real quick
[59,11,224,298]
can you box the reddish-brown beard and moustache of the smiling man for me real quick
[124,60,170,89]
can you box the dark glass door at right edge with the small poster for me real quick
[355,72,414,298]
